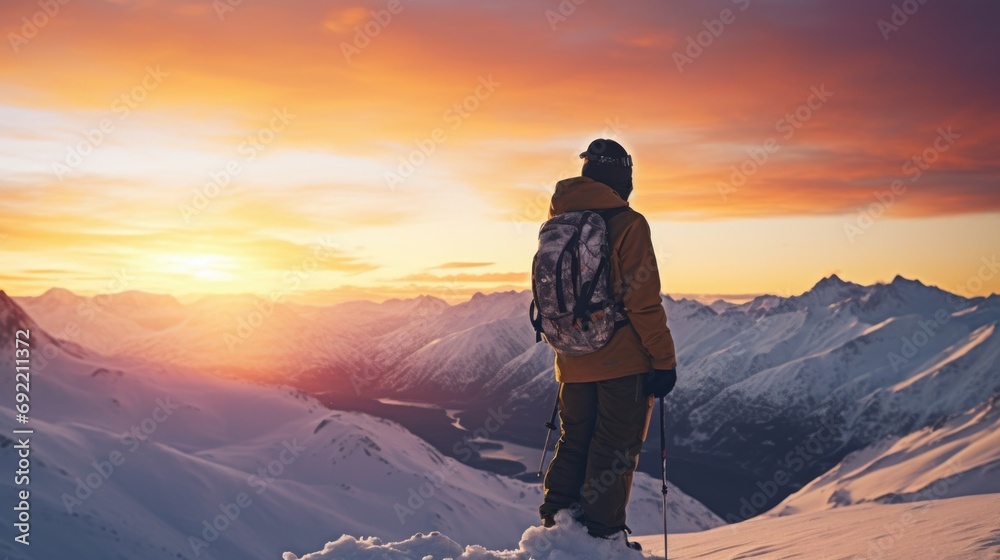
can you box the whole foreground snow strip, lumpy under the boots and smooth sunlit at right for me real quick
[283,494,1000,560]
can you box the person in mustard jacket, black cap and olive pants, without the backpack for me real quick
[539,139,677,549]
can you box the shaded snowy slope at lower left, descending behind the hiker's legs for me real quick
[0,292,721,560]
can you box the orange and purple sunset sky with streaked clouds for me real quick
[0,0,1000,302]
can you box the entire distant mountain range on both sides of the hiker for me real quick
[9,276,1000,520]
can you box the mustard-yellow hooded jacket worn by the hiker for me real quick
[549,177,677,383]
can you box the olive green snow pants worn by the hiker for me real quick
[538,374,654,536]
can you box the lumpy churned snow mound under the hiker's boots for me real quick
[283,511,645,560]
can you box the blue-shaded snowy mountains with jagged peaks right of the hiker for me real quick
[666,276,1000,516]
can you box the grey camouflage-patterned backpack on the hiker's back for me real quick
[528,206,629,356]
